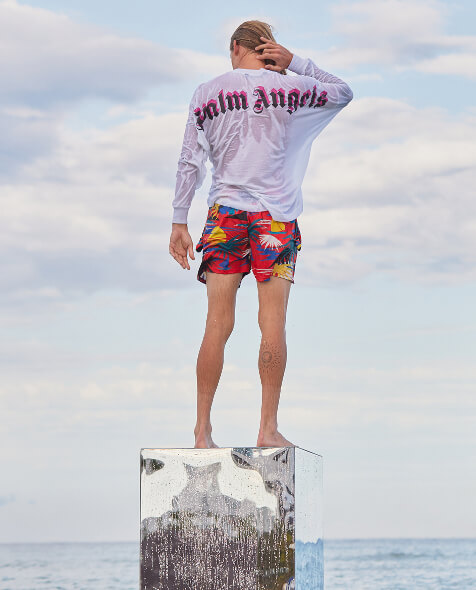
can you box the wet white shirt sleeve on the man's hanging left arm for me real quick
[172,89,209,223]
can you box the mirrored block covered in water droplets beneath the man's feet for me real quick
[140,447,323,590]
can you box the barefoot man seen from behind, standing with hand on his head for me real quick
[169,21,353,448]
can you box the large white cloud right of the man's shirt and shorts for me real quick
[298,98,476,284]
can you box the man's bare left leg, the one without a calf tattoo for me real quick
[194,272,243,448]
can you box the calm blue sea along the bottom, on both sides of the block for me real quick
[0,539,476,590]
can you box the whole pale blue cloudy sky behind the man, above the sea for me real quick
[0,0,476,542]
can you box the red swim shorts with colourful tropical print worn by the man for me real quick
[195,203,301,283]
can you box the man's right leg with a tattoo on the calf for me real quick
[256,276,292,447]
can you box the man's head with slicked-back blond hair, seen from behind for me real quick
[230,20,286,74]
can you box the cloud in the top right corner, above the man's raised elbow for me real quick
[300,0,476,78]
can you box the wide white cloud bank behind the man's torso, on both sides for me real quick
[0,98,476,314]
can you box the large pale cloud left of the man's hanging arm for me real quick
[0,105,205,320]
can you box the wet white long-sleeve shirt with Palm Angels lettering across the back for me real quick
[172,55,353,223]
